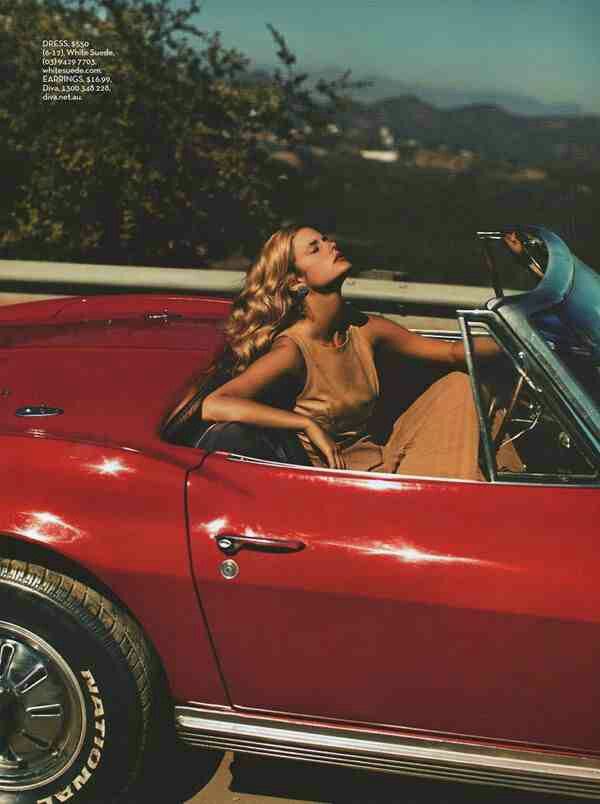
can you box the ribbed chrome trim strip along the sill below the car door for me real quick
[175,704,600,798]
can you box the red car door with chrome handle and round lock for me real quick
[188,453,600,750]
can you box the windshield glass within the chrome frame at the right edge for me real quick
[531,259,600,407]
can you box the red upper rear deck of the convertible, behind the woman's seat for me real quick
[0,296,229,462]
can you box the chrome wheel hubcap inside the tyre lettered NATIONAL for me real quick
[0,621,86,792]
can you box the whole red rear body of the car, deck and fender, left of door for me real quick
[0,295,236,703]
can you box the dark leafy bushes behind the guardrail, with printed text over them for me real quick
[0,0,351,266]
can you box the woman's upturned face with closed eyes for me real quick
[294,227,351,290]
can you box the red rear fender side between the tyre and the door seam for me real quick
[0,436,226,703]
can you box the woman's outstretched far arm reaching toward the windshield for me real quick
[367,316,502,368]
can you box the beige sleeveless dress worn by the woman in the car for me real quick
[277,324,482,480]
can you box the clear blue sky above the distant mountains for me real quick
[182,0,600,114]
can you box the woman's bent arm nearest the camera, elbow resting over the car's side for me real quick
[202,338,345,469]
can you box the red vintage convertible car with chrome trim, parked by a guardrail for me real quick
[0,227,600,804]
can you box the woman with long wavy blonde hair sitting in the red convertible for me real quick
[202,226,498,480]
